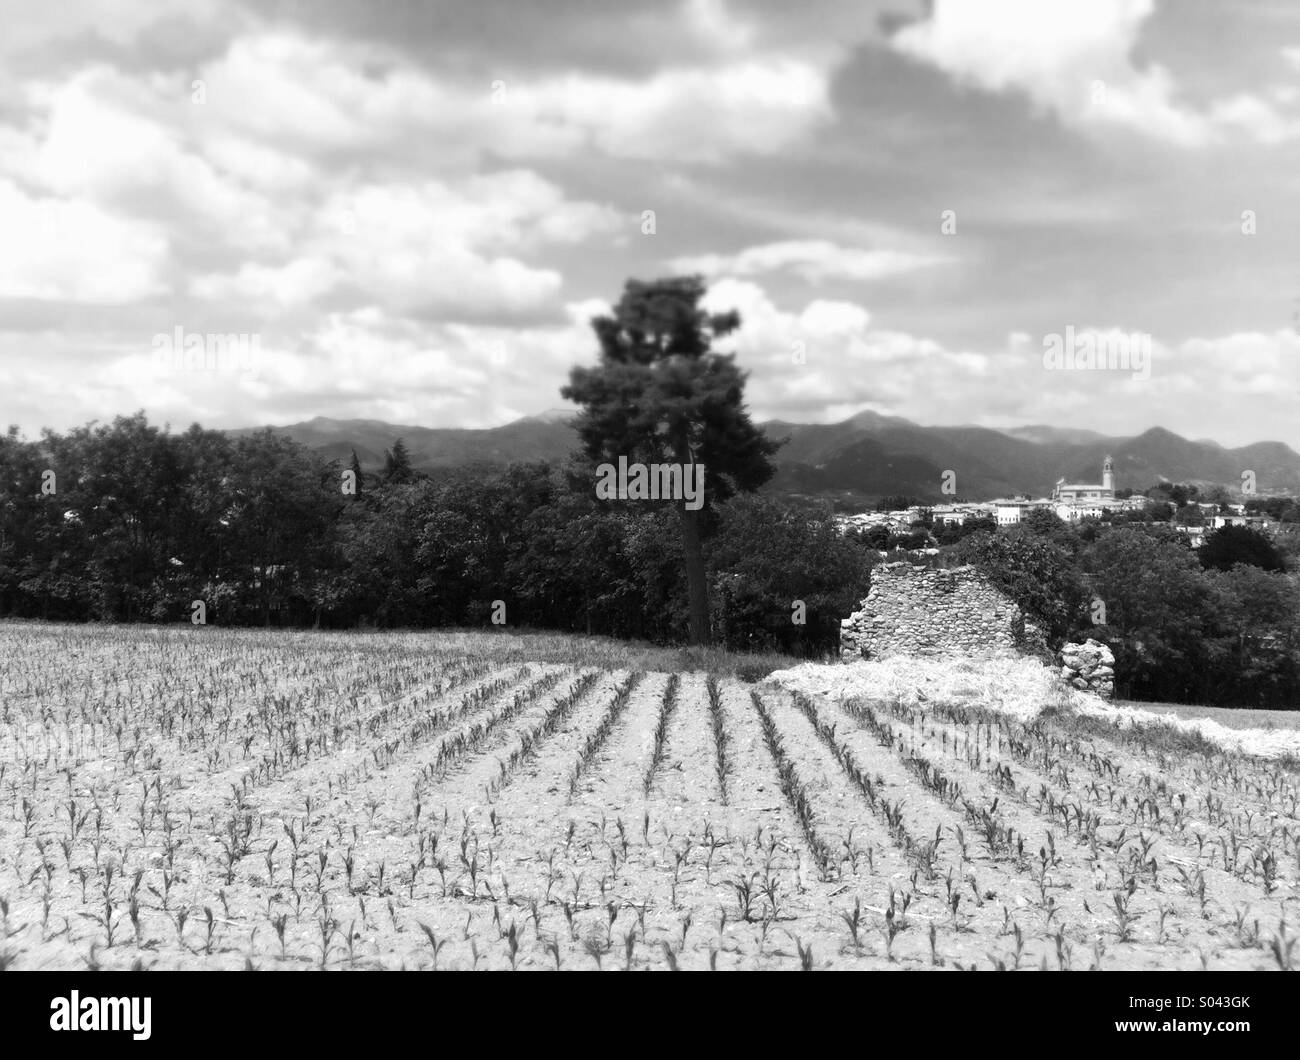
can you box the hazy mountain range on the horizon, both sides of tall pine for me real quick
[228,410,1300,502]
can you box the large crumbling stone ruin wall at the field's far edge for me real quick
[840,562,1045,659]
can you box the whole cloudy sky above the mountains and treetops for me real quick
[0,0,1300,449]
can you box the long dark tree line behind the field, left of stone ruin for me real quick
[0,414,868,654]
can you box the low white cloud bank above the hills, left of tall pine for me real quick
[10,299,610,427]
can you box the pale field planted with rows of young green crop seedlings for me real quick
[0,624,1300,970]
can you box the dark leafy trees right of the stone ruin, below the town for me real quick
[953,518,1300,708]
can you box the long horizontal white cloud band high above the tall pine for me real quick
[191,34,833,168]
